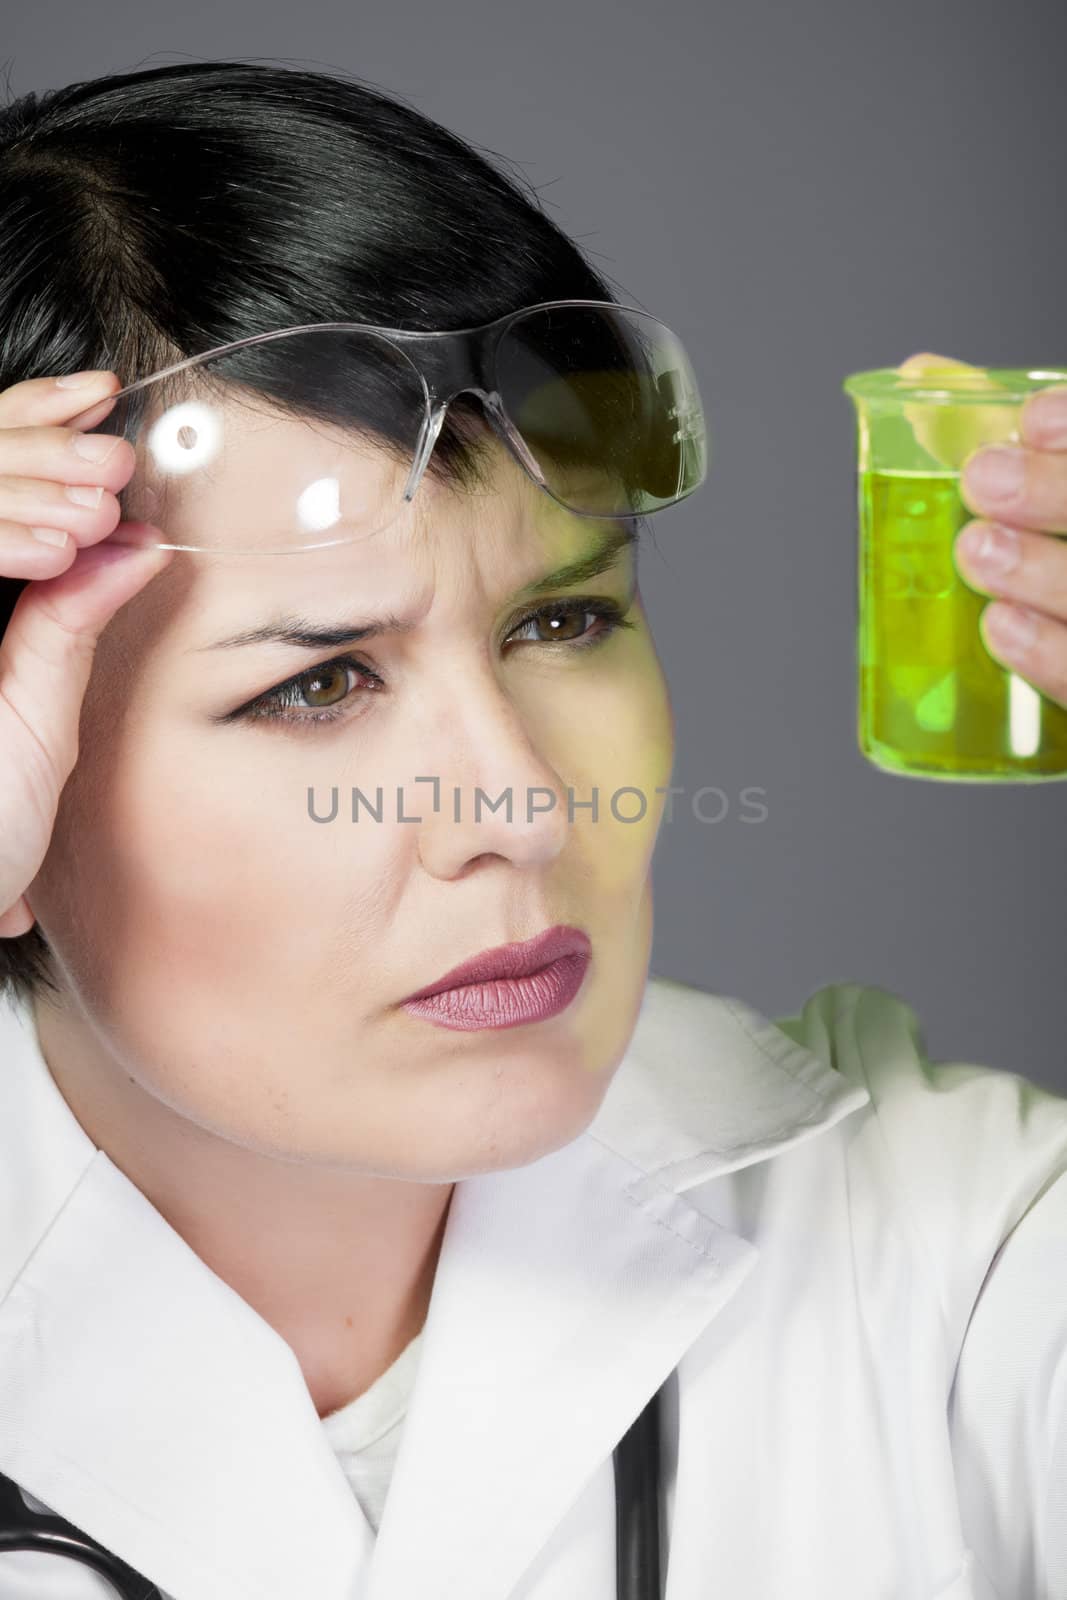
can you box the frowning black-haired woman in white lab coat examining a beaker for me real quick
[0,53,1067,1600]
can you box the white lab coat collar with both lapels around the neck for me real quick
[0,976,870,1600]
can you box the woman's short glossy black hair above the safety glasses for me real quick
[0,61,630,998]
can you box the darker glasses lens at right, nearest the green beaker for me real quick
[496,306,707,517]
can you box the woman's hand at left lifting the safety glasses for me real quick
[0,371,173,939]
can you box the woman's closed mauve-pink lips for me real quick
[403,923,592,1030]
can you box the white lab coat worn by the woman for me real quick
[0,976,1067,1600]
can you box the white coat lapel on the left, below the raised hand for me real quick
[0,1006,374,1600]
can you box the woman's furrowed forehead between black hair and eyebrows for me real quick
[119,406,624,651]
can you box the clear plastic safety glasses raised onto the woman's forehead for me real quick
[64,299,707,554]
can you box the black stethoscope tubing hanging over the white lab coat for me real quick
[0,1390,661,1600]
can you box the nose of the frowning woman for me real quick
[413,674,575,878]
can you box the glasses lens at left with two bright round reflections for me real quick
[74,328,429,554]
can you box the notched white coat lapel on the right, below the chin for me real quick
[368,979,870,1600]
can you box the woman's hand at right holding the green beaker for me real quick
[910,355,1067,707]
